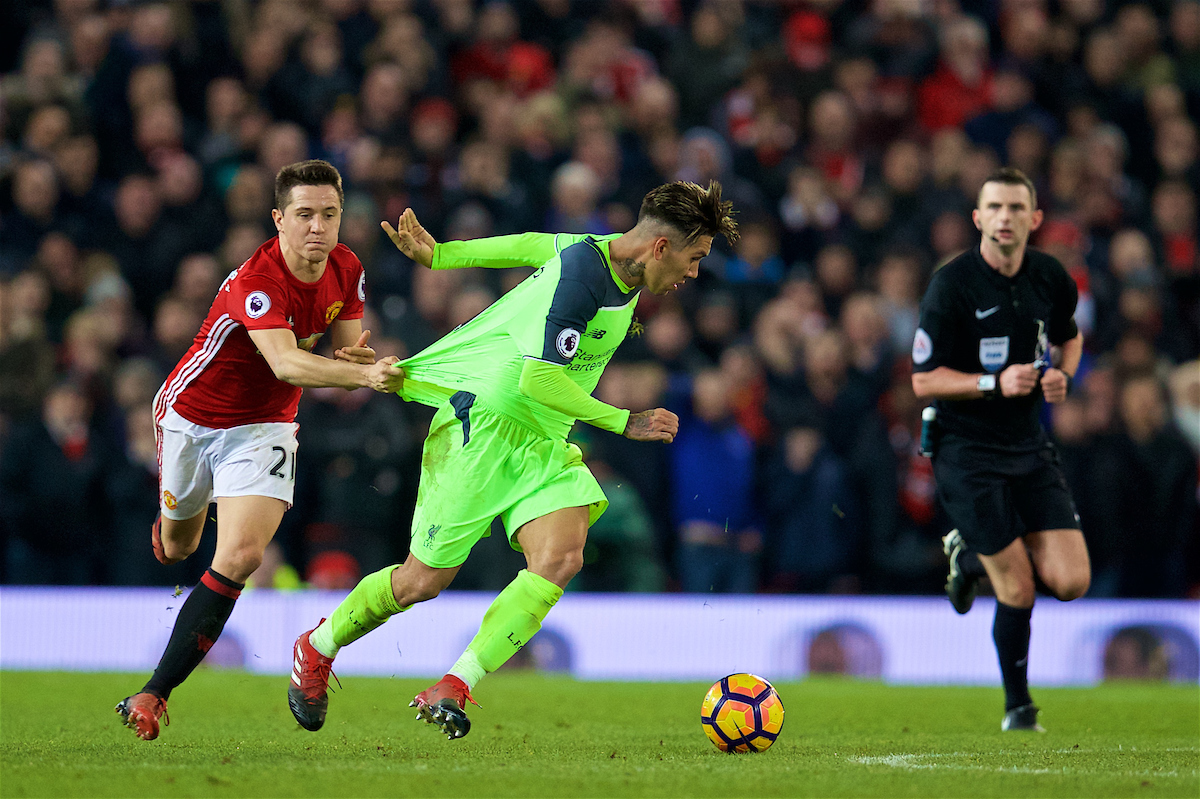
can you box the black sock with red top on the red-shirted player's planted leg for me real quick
[142,569,246,699]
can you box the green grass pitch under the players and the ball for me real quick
[0,669,1200,799]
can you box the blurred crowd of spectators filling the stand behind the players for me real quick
[0,0,1200,596]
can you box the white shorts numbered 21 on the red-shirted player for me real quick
[155,400,300,521]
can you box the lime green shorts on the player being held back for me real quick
[409,391,608,569]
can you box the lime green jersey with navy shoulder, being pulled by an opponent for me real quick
[400,233,637,439]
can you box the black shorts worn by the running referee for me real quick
[934,434,1079,555]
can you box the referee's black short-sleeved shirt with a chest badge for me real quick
[912,245,1079,451]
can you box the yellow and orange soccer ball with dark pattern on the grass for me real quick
[700,674,784,752]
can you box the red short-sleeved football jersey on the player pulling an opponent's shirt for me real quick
[155,236,366,428]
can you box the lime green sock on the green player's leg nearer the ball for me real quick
[450,569,563,689]
